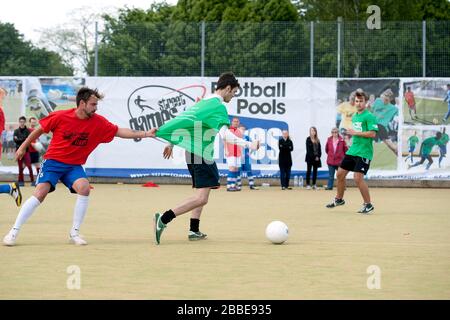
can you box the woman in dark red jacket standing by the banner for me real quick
[325,128,348,190]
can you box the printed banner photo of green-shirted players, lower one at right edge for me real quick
[402,126,450,175]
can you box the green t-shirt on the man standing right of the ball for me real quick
[347,110,378,160]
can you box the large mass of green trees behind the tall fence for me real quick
[89,0,450,77]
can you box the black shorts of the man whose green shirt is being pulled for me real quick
[186,152,220,189]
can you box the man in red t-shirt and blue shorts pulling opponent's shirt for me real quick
[3,88,156,246]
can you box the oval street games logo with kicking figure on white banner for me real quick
[127,85,206,141]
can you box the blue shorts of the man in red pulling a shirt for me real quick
[36,159,87,193]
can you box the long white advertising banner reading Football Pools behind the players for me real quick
[0,77,450,179]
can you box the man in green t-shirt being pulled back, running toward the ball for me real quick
[154,72,259,244]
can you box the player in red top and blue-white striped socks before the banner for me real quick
[225,117,242,191]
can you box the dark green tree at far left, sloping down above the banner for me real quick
[0,23,73,76]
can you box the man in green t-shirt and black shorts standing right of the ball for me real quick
[327,90,378,214]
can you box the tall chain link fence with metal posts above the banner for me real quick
[93,21,450,78]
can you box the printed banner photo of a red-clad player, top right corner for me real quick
[403,80,450,126]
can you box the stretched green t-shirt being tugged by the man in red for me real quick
[156,96,230,161]
